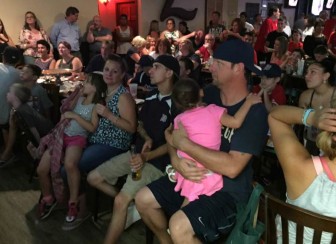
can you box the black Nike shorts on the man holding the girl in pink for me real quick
[148,177,237,242]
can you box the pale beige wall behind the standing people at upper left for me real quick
[0,0,98,43]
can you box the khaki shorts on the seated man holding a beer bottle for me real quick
[95,151,163,198]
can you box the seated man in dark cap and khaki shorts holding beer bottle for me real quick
[88,55,180,243]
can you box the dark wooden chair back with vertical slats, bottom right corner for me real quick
[263,193,336,244]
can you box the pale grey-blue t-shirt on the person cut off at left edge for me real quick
[0,63,20,125]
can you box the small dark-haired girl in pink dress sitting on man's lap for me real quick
[172,79,261,206]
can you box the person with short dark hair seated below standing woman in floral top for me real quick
[35,40,56,70]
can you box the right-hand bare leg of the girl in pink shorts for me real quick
[64,146,83,203]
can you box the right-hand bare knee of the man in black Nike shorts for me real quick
[169,210,194,243]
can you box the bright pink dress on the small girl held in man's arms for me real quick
[174,104,226,202]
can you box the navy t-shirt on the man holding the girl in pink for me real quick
[203,85,268,201]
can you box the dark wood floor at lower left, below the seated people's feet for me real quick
[0,154,156,244]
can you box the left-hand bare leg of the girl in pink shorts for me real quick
[36,150,53,197]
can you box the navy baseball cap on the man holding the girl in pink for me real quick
[213,39,262,75]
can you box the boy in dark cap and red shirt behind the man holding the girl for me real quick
[253,64,286,112]
